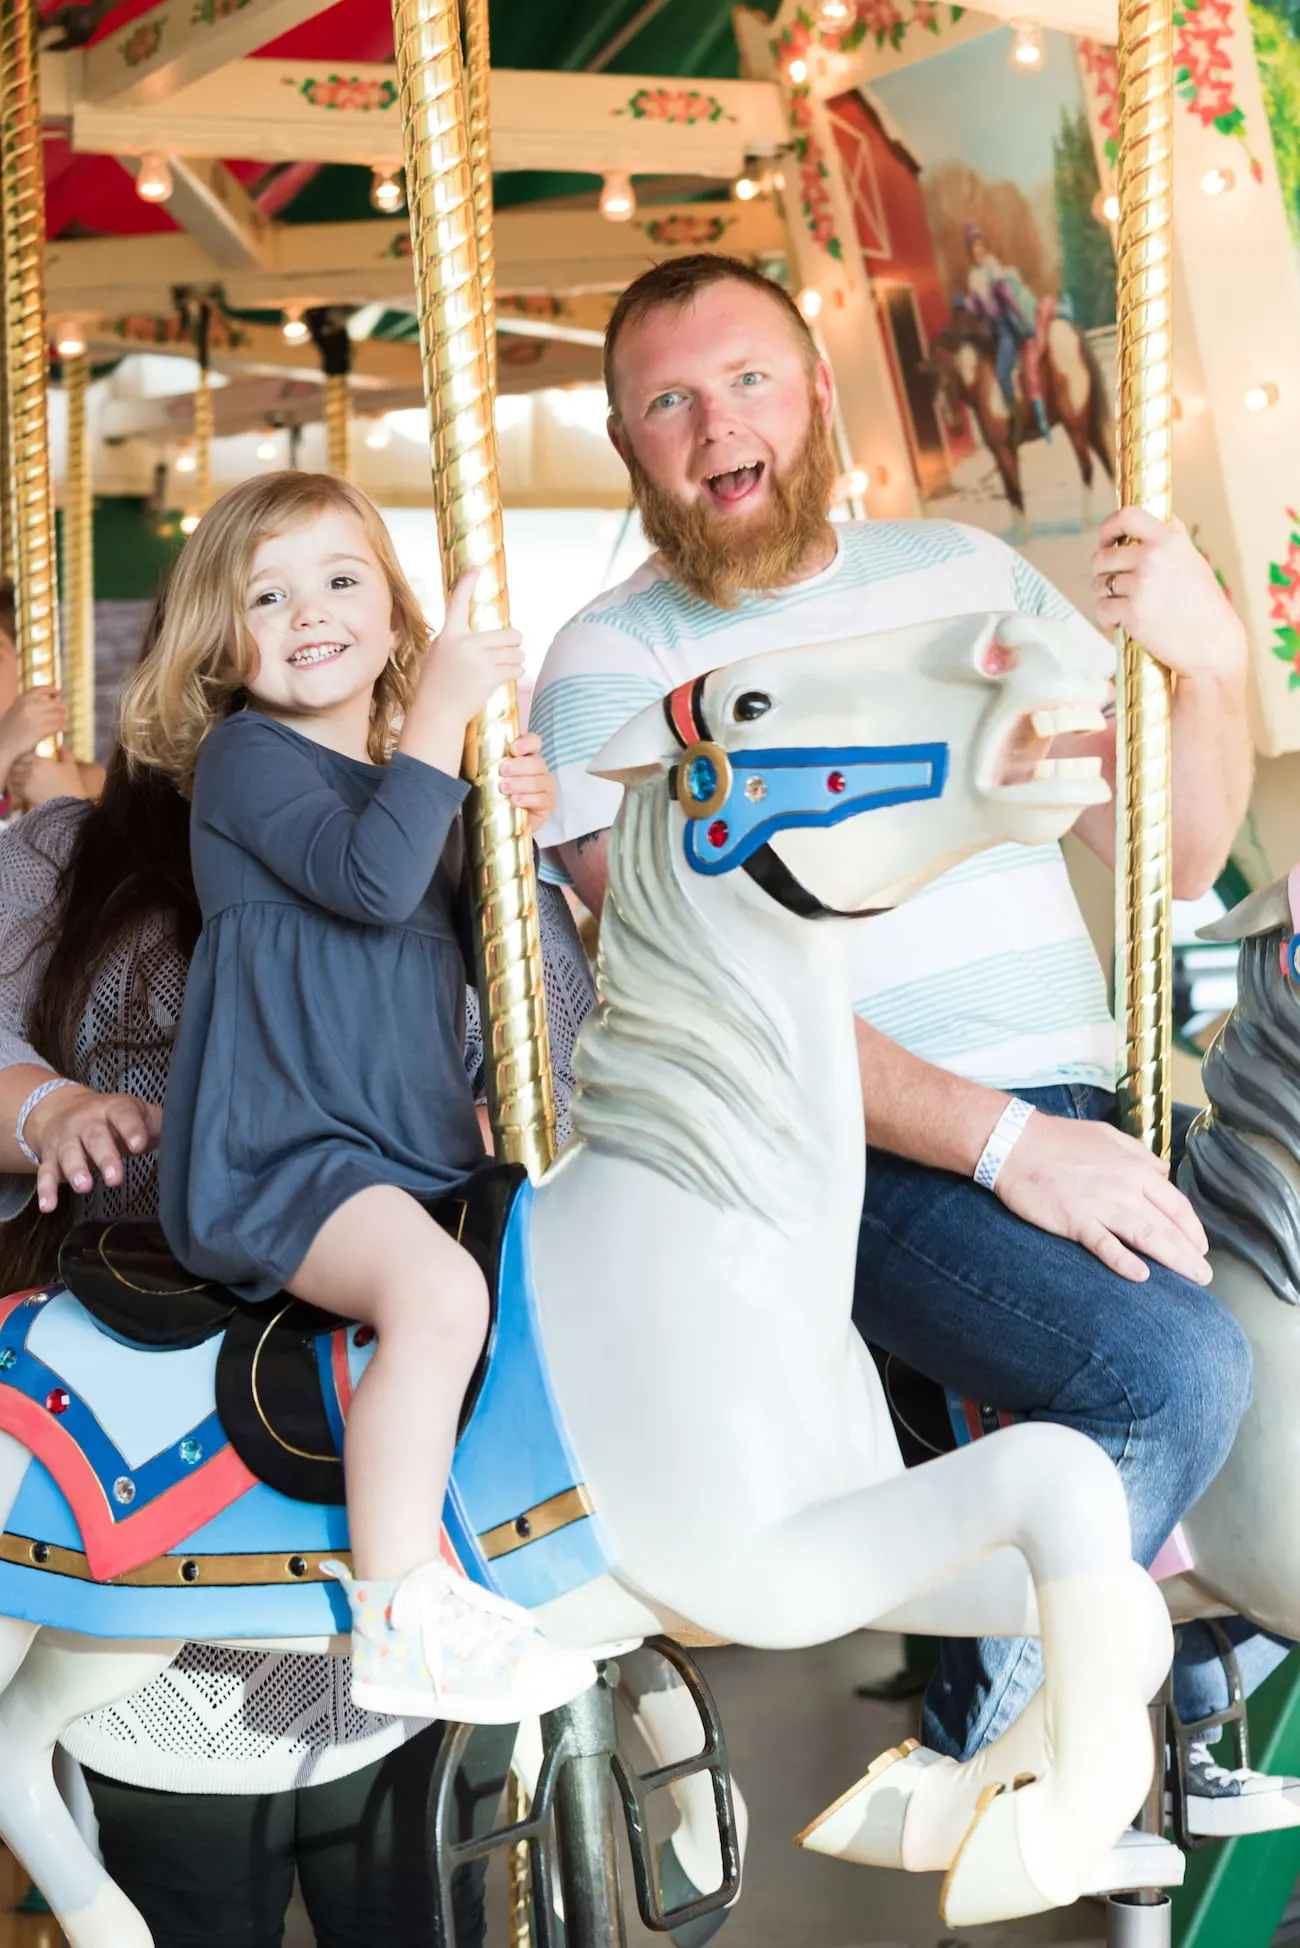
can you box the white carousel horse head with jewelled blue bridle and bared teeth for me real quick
[591,616,1111,918]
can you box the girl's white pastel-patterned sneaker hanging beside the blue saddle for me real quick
[322,1558,596,1724]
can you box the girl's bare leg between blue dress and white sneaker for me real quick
[288,1184,487,1582]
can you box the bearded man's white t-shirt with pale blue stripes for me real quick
[530,520,1115,1089]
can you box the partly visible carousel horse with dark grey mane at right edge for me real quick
[1179,869,1300,1638]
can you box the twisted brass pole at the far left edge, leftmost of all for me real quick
[0,0,58,690]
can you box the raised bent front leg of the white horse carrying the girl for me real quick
[655,1424,1169,1925]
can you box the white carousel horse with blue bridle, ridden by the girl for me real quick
[0,618,1169,1948]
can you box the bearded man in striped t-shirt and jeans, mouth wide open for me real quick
[532,255,1284,1831]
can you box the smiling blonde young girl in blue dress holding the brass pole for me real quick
[123,473,594,1724]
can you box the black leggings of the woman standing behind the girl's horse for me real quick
[86,1726,515,1948]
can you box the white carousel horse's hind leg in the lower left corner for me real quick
[0,1630,179,1948]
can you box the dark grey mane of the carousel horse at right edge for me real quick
[1179,931,1300,1305]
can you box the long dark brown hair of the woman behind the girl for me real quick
[0,582,201,1292]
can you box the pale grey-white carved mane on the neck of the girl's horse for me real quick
[573,783,811,1231]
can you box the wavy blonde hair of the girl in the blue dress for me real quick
[121,473,429,795]
